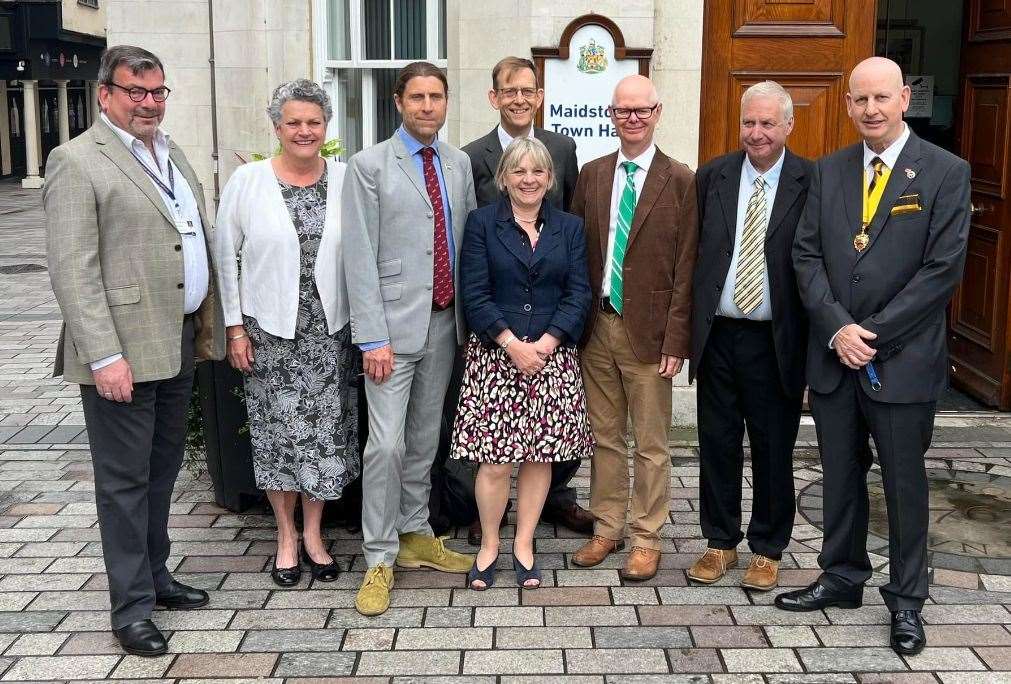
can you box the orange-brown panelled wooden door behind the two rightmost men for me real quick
[699,0,877,164]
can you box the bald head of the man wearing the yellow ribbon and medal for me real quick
[846,57,909,154]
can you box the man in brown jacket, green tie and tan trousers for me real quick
[572,76,699,580]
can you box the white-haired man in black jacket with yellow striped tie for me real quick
[687,81,812,591]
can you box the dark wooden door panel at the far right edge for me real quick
[949,0,1011,410]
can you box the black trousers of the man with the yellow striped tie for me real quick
[697,316,803,560]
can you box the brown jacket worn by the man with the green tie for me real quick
[572,150,699,364]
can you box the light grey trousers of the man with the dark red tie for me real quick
[362,308,456,568]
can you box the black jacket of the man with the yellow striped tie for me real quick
[688,150,814,396]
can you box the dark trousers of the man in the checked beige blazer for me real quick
[81,316,193,629]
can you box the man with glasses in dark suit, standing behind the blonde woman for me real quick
[446,57,593,546]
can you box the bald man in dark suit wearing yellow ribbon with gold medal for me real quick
[775,58,970,655]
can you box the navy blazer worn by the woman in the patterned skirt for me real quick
[460,198,592,345]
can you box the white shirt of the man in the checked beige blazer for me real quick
[91,112,210,371]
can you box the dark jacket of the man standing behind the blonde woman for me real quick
[463,126,579,211]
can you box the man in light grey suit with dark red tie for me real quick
[342,62,474,615]
